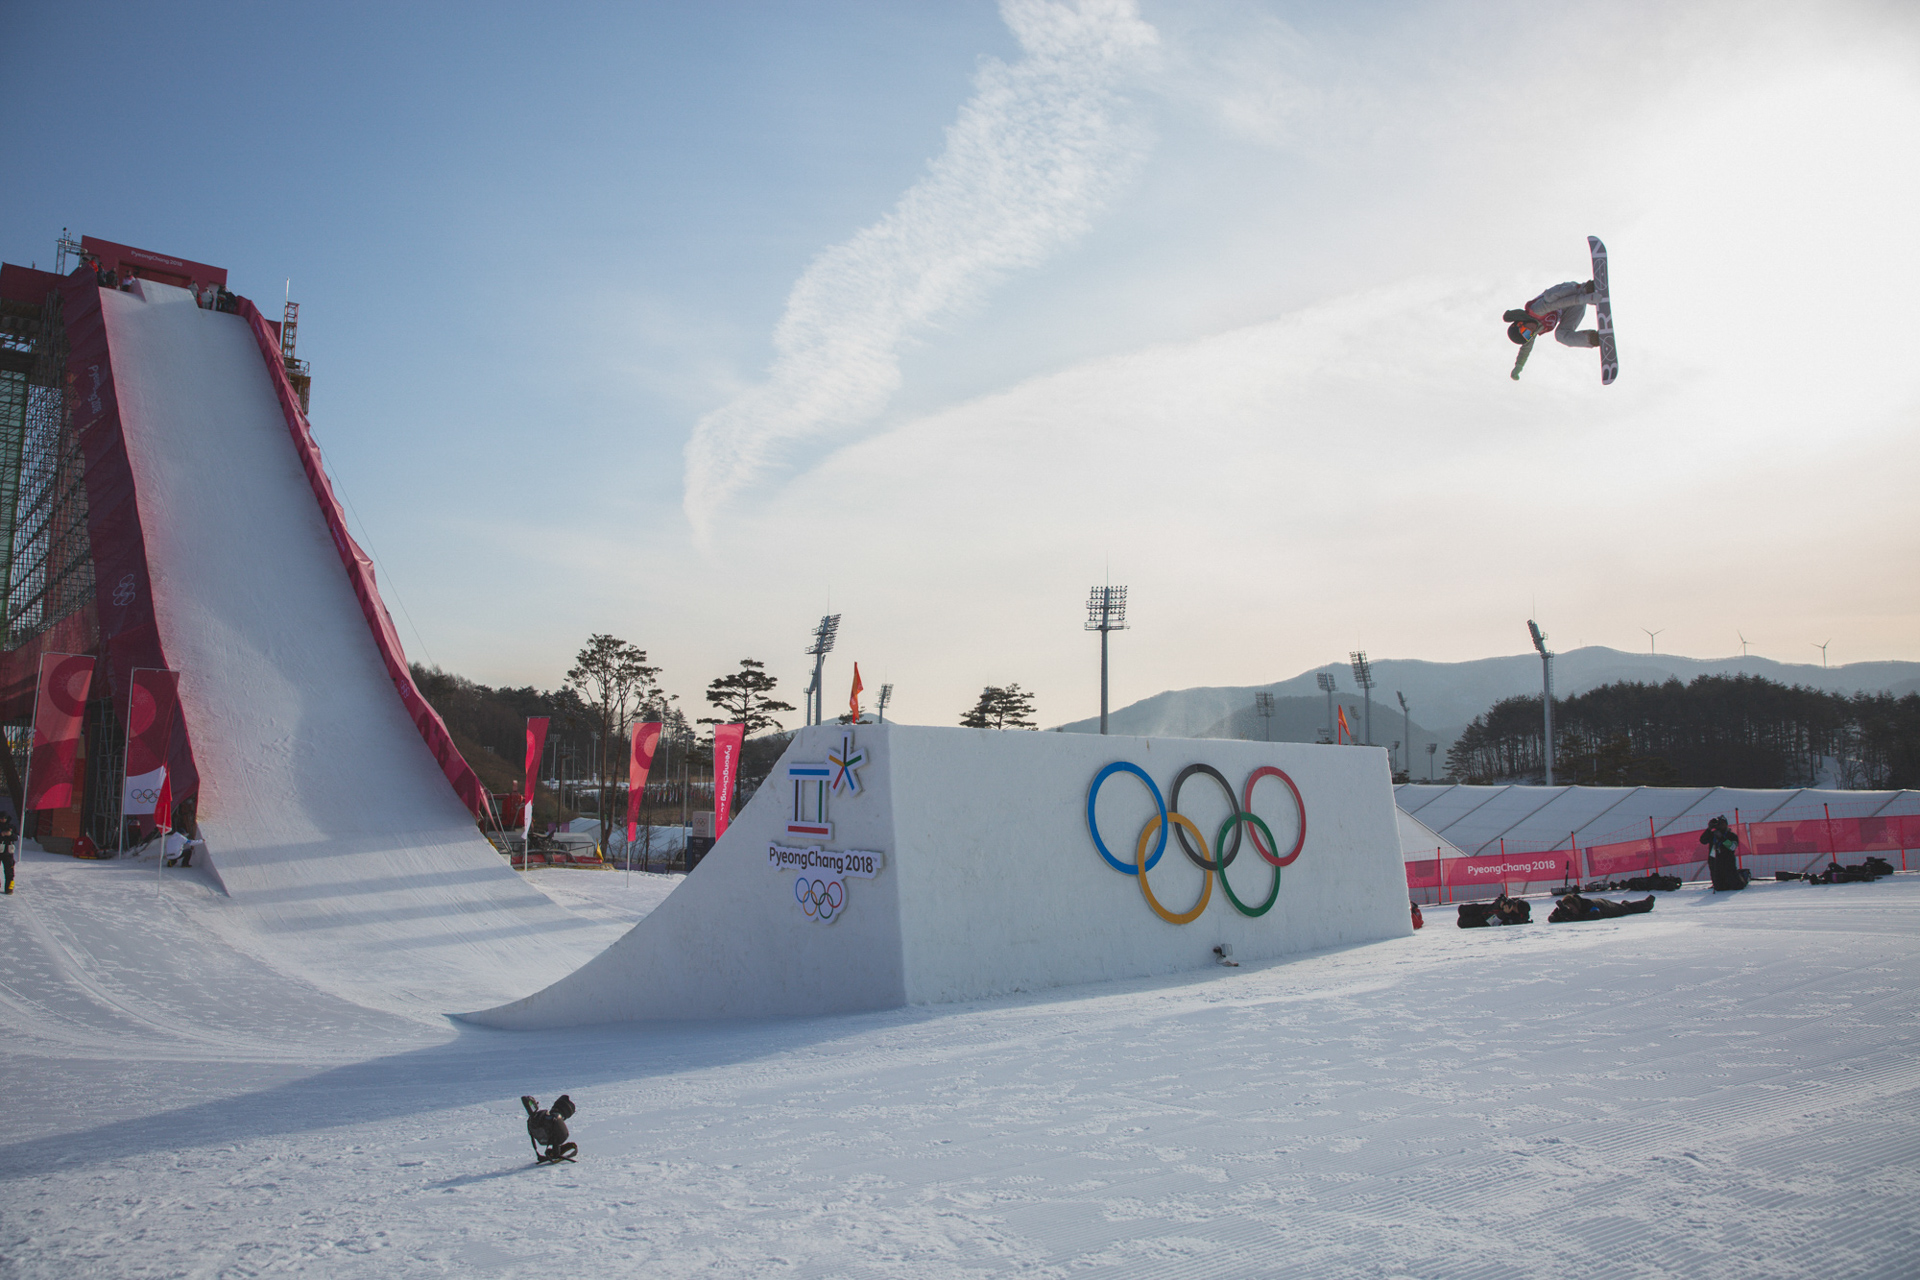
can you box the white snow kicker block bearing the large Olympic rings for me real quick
[465,725,1411,1029]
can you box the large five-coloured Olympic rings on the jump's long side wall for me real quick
[1087,760,1308,925]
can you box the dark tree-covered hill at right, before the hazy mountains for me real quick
[1448,676,1920,789]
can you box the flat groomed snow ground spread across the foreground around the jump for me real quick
[0,856,1920,1280]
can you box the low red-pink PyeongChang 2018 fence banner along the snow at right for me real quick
[1407,804,1920,904]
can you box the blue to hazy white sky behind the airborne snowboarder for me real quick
[0,0,1920,723]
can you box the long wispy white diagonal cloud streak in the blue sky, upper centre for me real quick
[685,0,1158,537]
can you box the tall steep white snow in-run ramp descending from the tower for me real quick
[93,280,609,1011]
